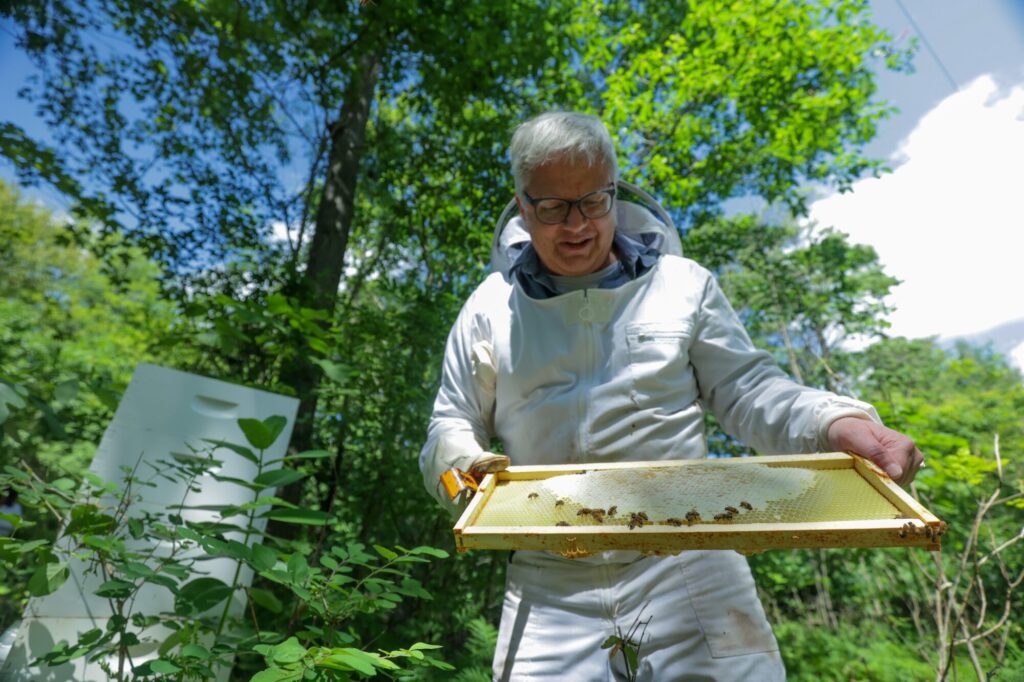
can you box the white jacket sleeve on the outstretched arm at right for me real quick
[690,272,881,455]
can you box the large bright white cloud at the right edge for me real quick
[810,76,1024,338]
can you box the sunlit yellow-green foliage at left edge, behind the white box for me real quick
[0,183,174,473]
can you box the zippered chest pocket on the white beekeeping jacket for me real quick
[626,323,694,410]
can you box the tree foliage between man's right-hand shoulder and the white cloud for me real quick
[685,216,898,391]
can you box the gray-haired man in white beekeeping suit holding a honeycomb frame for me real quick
[420,113,923,680]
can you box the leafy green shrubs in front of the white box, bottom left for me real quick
[0,417,452,680]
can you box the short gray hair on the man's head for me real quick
[509,112,618,194]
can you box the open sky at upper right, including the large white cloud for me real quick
[811,0,1024,366]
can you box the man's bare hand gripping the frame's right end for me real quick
[828,417,925,485]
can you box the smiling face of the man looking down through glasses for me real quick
[516,159,615,276]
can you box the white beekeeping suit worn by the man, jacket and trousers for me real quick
[420,187,878,679]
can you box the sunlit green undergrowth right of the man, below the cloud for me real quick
[751,339,1024,679]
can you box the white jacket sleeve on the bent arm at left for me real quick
[420,288,496,511]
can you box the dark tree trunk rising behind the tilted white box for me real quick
[278,50,381,503]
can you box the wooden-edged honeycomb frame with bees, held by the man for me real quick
[455,453,945,557]
